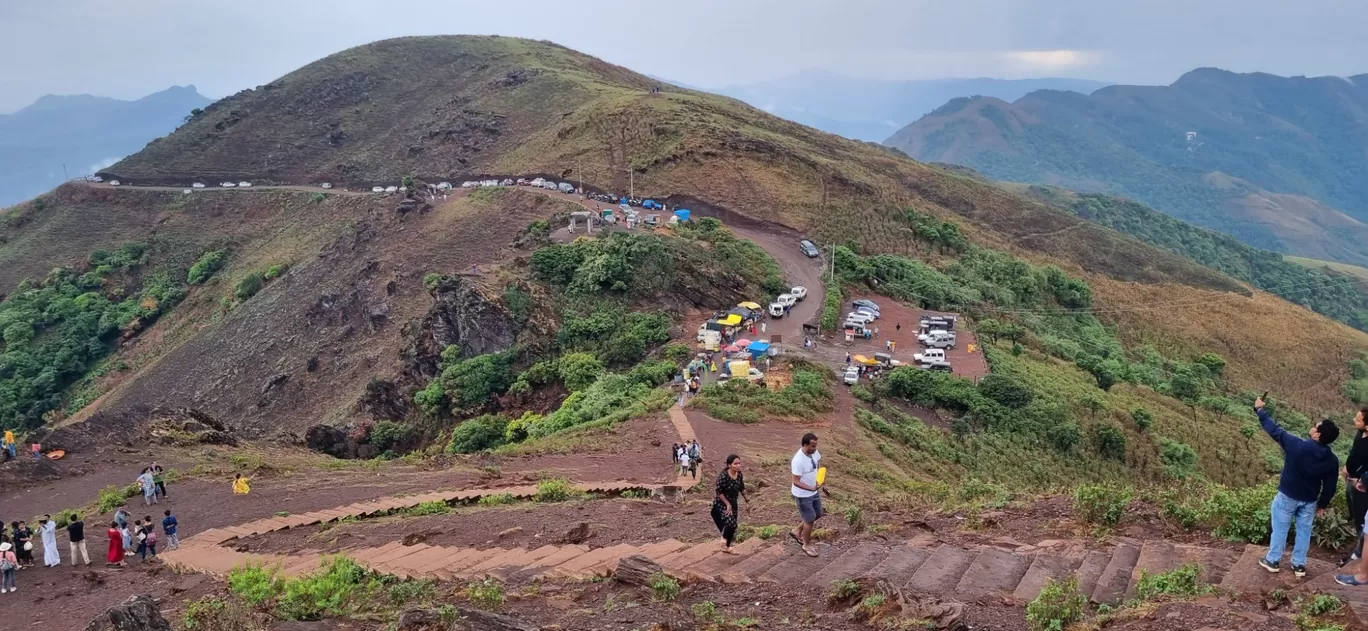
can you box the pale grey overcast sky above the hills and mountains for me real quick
[0,0,1368,112]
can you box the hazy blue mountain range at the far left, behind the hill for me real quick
[0,85,212,203]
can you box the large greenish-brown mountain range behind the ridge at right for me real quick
[885,68,1368,264]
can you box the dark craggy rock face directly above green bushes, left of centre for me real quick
[404,276,516,381]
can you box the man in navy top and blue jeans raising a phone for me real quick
[1254,397,1339,578]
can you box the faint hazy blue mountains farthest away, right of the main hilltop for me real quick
[705,70,1108,142]
